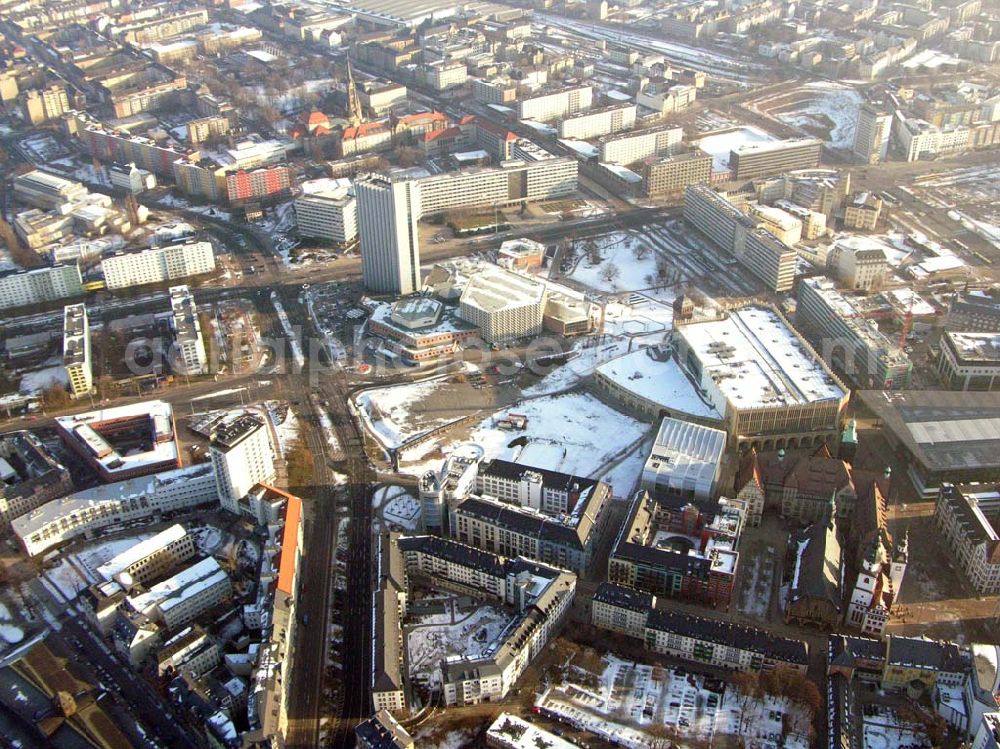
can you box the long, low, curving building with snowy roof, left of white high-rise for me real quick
[11,463,218,556]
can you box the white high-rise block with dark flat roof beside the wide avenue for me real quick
[209,413,276,515]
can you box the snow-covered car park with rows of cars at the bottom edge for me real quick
[536,656,811,749]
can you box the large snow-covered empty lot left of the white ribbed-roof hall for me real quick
[402,393,650,476]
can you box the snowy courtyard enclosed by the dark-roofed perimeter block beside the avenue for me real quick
[407,604,511,684]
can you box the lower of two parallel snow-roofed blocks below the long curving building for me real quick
[125,557,233,630]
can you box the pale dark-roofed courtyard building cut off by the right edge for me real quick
[932,484,1000,596]
